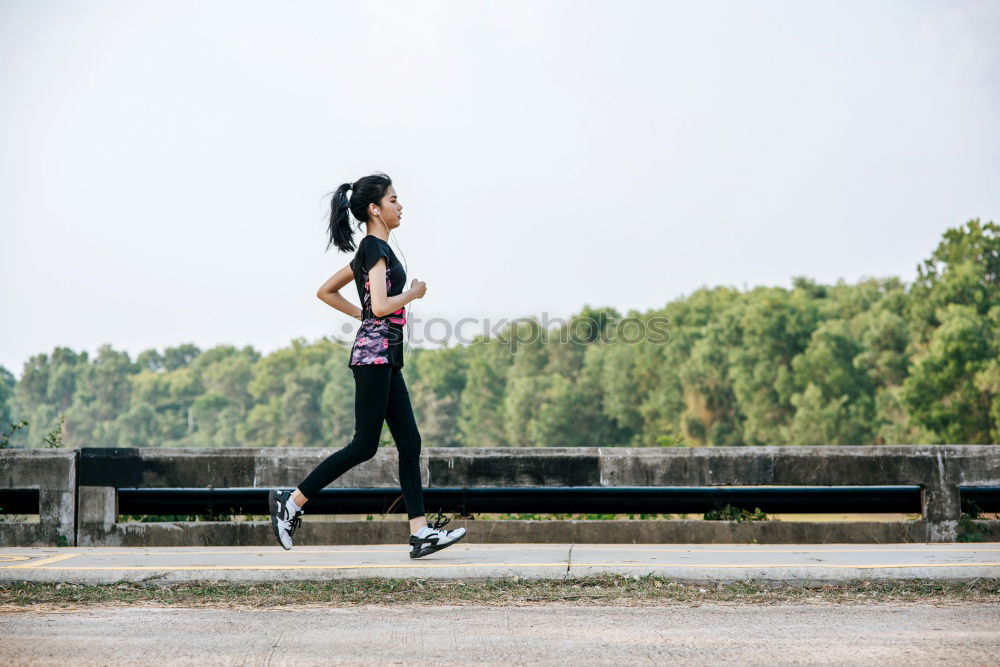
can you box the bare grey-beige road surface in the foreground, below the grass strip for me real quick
[0,603,1000,667]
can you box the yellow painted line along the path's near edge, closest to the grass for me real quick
[0,563,1000,571]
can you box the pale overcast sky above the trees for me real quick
[0,0,1000,377]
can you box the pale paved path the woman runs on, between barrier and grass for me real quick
[0,542,1000,583]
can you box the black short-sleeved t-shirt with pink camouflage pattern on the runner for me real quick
[348,234,406,366]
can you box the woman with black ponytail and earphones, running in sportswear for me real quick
[268,173,465,558]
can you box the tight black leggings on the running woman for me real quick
[298,364,424,519]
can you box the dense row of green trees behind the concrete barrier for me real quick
[0,219,1000,447]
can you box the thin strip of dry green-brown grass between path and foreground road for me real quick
[0,575,1000,610]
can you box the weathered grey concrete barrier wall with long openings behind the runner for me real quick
[0,445,1000,546]
